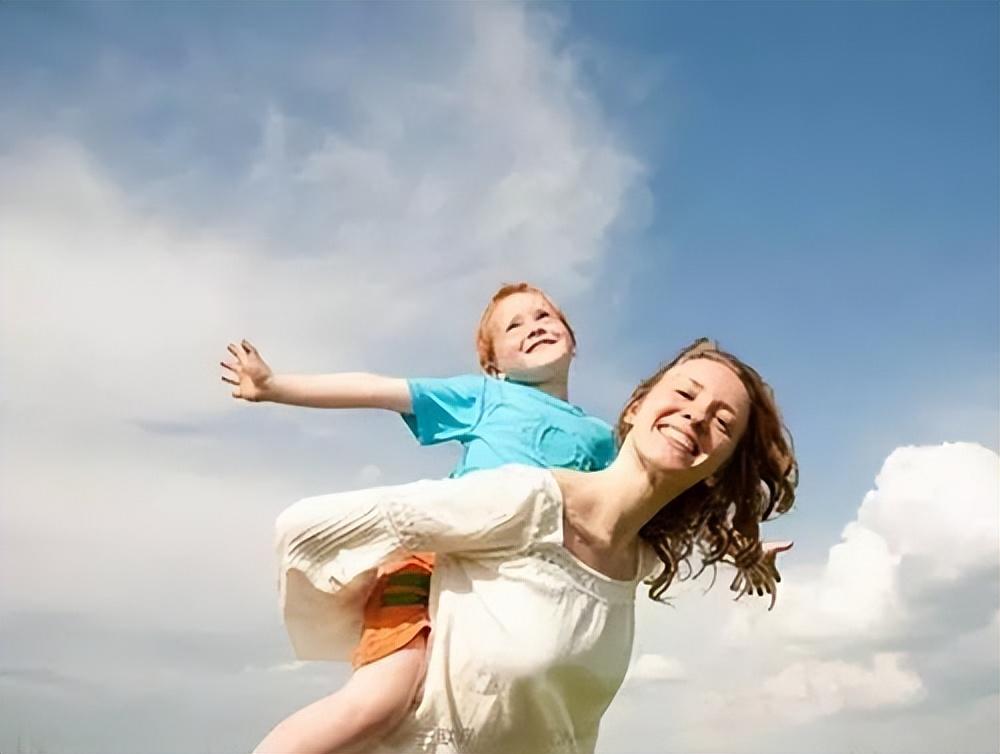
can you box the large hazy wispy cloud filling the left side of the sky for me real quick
[0,3,644,751]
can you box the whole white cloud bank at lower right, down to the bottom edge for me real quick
[602,443,1000,754]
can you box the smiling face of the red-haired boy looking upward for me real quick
[490,291,575,384]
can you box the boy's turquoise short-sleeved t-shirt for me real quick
[403,375,615,477]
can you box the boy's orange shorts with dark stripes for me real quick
[351,553,434,668]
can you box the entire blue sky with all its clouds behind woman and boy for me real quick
[0,2,1000,754]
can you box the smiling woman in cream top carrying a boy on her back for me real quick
[258,340,797,754]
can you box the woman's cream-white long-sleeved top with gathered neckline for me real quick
[277,466,659,754]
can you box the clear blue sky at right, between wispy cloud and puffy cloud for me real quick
[569,3,1000,548]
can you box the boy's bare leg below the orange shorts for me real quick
[254,633,426,754]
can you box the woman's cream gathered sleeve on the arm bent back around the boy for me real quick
[277,466,562,659]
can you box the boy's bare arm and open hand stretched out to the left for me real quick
[219,340,413,414]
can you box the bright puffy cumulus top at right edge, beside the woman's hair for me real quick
[764,443,1000,641]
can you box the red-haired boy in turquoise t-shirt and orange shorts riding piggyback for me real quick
[222,283,615,754]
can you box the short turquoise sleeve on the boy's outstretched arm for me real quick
[402,375,486,445]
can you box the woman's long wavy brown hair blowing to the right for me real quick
[616,338,798,606]
